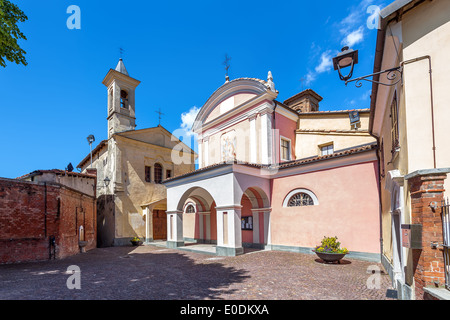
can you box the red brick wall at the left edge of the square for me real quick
[0,178,96,263]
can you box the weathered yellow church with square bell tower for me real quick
[77,59,196,247]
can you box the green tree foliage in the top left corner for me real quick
[0,0,28,67]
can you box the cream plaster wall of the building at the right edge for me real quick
[373,1,450,292]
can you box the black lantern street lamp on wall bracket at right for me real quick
[333,47,403,88]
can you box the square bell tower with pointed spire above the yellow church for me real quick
[102,59,140,139]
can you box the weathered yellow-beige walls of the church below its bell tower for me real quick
[83,127,195,239]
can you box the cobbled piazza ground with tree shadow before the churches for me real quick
[0,246,390,300]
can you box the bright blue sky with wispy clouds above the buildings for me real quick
[0,0,384,178]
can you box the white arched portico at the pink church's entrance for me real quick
[166,163,270,256]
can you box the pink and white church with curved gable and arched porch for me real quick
[164,72,380,261]
